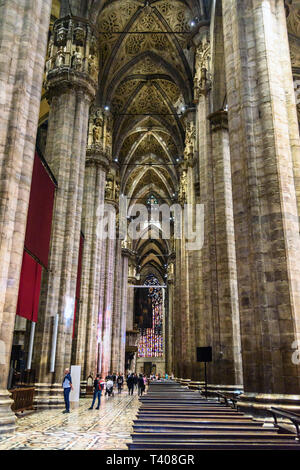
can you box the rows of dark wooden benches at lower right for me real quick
[128,382,300,450]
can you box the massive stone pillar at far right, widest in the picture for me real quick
[222,0,300,412]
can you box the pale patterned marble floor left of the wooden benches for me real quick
[0,391,139,450]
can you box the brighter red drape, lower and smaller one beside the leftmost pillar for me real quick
[17,251,42,322]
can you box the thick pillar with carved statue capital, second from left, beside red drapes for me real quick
[35,17,97,406]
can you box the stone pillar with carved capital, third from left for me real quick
[75,107,111,380]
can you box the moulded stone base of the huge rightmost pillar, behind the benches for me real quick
[237,393,300,421]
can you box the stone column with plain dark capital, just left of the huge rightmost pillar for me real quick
[208,111,242,390]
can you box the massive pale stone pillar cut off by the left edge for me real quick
[0,0,51,433]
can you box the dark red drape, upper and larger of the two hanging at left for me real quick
[25,153,55,268]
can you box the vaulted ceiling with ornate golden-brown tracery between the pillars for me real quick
[97,0,207,276]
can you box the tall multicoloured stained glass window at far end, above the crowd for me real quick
[138,274,163,357]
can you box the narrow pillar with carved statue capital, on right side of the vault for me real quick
[193,34,217,382]
